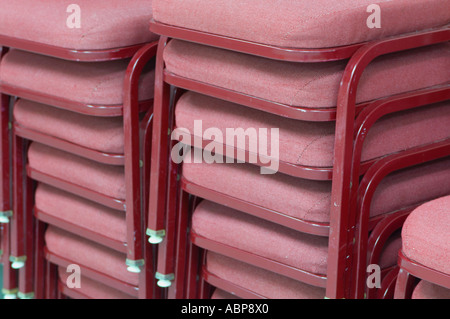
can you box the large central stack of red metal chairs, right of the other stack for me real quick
[147,0,450,298]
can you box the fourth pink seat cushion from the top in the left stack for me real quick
[28,142,125,200]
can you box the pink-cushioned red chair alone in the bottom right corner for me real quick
[394,196,450,299]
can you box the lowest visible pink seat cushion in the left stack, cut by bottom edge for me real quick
[58,267,135,299]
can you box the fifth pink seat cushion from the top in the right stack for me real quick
[192,200,399,282]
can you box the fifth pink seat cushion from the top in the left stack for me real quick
[35,183,126,243]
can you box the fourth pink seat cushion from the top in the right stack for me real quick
[183,152,450,223]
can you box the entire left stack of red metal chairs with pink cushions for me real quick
[0,0,159,298]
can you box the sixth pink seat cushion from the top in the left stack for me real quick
[45,225,139,286]
